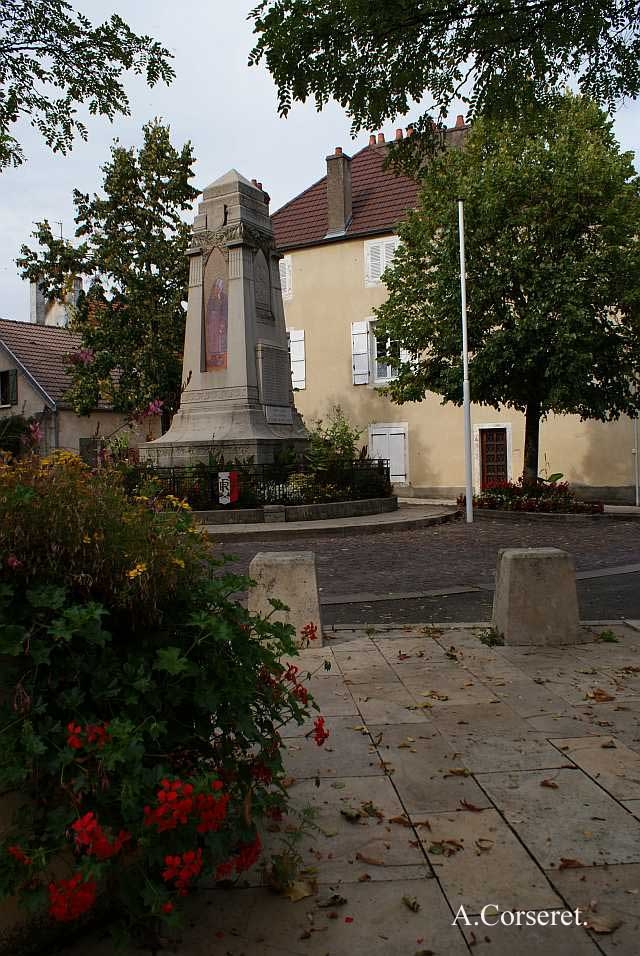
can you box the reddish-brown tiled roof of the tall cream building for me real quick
[271,144,418,251]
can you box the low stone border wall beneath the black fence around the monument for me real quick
[194,495,398,525]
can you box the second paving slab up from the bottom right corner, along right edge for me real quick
[476,769,640,869]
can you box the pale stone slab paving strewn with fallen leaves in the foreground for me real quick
[69,622,640,956]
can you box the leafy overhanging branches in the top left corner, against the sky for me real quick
[0,0,174,170]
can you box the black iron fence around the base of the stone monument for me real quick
[119,459,391,511]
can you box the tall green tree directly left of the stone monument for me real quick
[18,121,198,422]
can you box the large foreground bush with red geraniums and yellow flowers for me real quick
[0,454,327,939]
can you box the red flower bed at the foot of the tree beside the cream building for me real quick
[458,478,604,514]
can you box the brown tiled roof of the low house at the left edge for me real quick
[0,319,81,405]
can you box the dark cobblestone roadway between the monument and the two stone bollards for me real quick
[216,519,640,596]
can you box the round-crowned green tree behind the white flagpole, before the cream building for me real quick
[376,95,640,480]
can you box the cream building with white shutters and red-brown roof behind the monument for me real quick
[273,127,634,502]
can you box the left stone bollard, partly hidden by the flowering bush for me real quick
[248,551,322,647]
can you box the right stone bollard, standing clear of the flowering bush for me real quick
[492,548,580,646]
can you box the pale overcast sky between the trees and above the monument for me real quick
[0,0,640,320]
